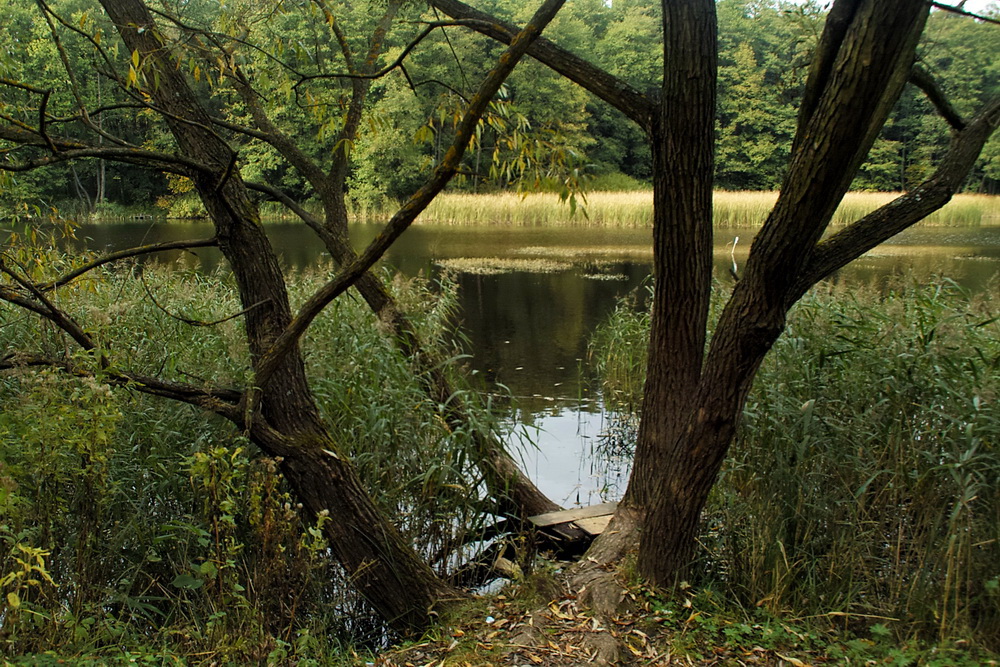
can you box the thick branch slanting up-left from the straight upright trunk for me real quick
[431,0,653,130]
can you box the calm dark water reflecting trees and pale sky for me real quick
[80,223,1000,505]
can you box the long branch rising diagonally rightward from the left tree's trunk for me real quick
[255,0,565,386]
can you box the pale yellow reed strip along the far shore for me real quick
[419,190,1000,228]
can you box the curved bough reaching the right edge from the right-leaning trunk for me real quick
[789,96,1000,302]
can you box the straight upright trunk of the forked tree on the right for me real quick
[625,0,716,508]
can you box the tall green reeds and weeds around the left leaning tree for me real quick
[0,255,491,664]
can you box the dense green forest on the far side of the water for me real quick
[0,0,1000,215]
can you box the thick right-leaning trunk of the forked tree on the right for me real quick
[629,0,929,585]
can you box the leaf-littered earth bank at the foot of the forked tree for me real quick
[372,562,998,667]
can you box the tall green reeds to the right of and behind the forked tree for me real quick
[596,282,1000,650]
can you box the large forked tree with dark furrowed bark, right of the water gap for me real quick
[432,0,1000,586]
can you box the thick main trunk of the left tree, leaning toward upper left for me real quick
[102,0,460,630]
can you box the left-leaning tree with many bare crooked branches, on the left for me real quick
[0,0,562,630]
